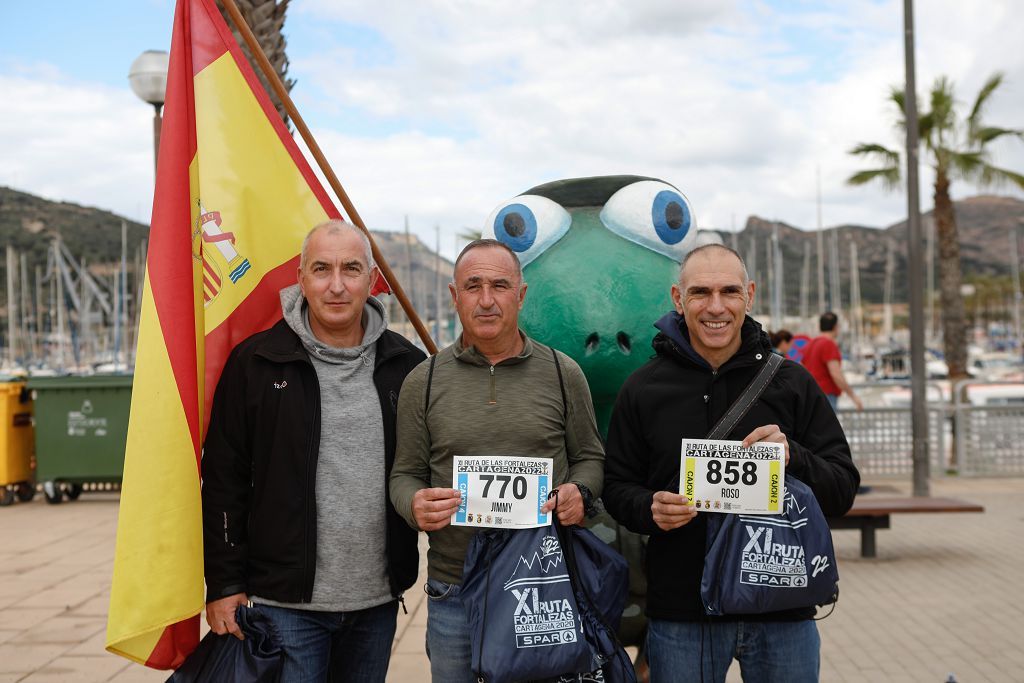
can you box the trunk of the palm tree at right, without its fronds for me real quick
[934,170,968,381]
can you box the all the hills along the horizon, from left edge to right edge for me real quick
[0,186,1024,313]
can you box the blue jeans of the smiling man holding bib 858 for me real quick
[647,620,821,683]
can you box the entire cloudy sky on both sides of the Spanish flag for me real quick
[0,0,1024,253]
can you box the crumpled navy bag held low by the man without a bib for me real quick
[167,605,284,683]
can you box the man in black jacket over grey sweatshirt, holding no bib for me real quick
[203,221,424,682]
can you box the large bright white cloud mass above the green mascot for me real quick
[286,0,1024,250]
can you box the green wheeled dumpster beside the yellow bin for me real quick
[28,375,132,504]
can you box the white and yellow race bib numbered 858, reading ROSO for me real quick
[679,438,785,515]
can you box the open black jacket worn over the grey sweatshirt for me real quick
[203,321,425,603]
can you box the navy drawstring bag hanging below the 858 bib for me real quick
[700,476,839,615]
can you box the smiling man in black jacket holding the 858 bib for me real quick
[604,245,860,683]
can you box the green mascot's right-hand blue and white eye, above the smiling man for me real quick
[601,180,697,261]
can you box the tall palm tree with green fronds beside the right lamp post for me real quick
[847,73,1024,380]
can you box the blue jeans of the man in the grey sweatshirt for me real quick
[250,600,398,683]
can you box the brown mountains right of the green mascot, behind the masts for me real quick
[721,196,1024,314]
